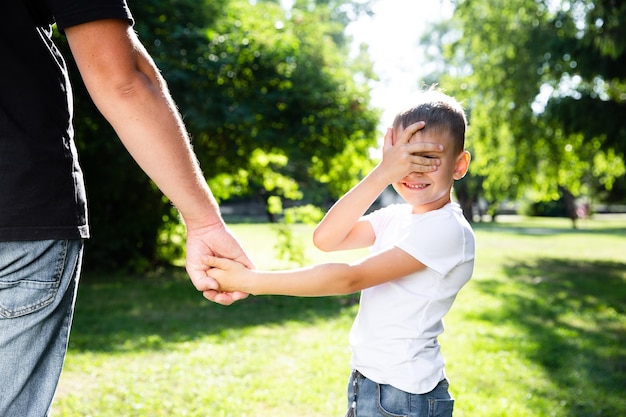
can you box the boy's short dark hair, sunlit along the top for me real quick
[393,89,467,154]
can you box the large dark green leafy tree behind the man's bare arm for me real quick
[59,0,379,270]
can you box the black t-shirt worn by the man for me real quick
[0,0,132,241]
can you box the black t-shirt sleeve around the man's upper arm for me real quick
[50,0,134,31]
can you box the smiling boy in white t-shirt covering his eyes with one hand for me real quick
[206,90,474,417]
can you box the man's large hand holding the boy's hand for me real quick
[186,223,254,305]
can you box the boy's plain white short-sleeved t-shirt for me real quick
[350,203,475,394]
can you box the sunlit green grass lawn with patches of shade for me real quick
[53,217,626,417]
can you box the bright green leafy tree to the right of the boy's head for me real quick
[423,0,626,223]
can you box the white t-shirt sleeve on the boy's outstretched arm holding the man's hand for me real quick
[396,210,469,276]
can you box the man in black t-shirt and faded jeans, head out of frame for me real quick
[0,0,252,417]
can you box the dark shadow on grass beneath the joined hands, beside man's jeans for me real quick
[69,269,358,352]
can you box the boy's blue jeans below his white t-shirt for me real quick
[348,372,454,417]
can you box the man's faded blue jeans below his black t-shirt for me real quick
[0,240,83,417]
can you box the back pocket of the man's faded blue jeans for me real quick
[0,240,68,319]
